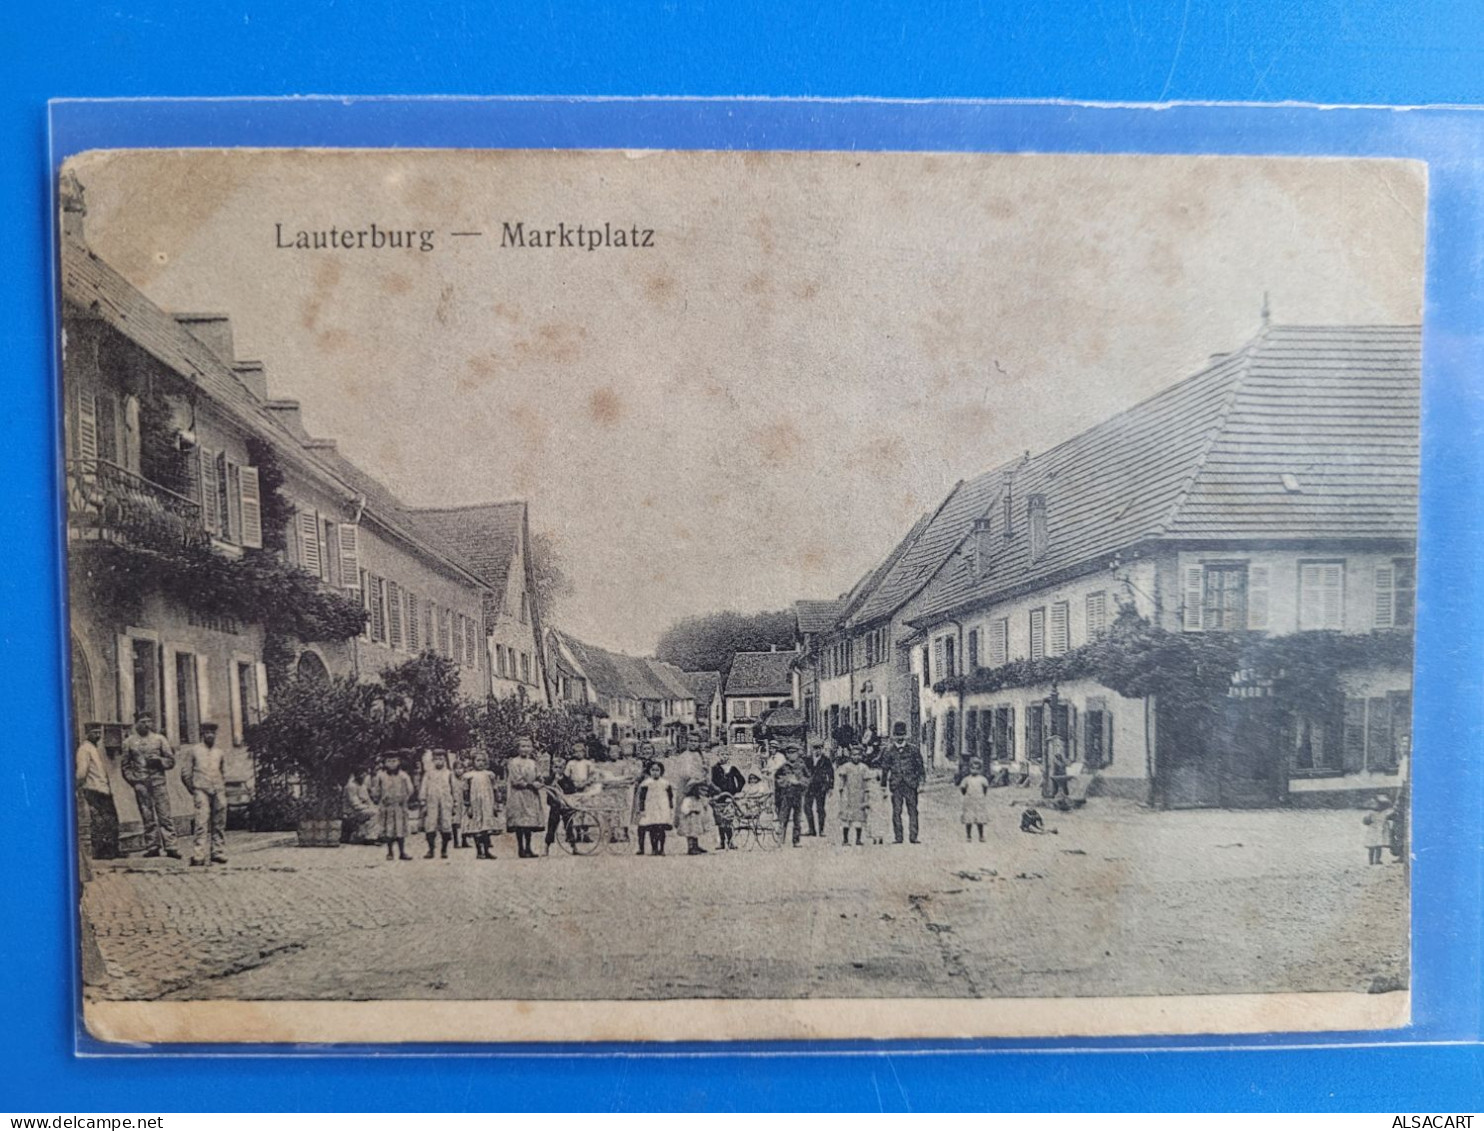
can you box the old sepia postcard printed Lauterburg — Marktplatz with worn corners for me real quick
[58,150,1428,1042]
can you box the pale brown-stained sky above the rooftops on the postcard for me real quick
[73,150,1425,652]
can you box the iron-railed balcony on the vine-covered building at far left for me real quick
[67,459,211,552]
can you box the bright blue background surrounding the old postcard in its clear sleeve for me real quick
[0,0,1484,1112]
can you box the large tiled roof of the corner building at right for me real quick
[914,327,1420,620]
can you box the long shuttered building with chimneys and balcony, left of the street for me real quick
[59,177,540,837]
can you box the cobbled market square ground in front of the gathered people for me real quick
[83,784,1407,999]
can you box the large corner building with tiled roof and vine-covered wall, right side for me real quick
[895,325,1420,806]
